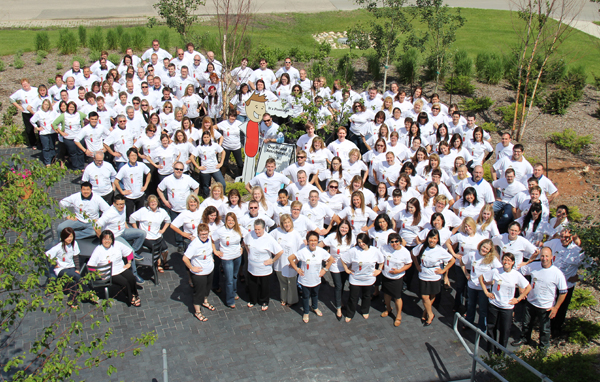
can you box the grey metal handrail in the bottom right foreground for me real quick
[453,312,552,382]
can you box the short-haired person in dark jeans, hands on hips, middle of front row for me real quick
[288,231,335,324]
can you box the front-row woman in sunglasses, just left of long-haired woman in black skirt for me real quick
[380,233,412,326]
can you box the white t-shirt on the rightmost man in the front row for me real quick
[520,262,568,309]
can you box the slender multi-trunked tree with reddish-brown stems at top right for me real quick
[512,0,583,141]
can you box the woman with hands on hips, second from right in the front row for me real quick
[479,252,531,355]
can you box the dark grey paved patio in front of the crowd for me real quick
[0,149,488,382]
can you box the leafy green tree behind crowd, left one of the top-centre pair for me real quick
[348,0,412,89]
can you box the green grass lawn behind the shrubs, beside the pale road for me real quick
[0,9,600,80]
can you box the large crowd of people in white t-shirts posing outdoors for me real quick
[24,40,583,352]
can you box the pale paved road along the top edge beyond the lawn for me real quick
[0,0,600,38]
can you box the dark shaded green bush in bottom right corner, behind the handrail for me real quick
[485,349,598,382]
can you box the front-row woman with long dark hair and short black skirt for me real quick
[411,228,455,326]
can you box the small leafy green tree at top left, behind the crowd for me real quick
[148,0,206,40]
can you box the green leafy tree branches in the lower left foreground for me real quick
[0,156,156,381]
